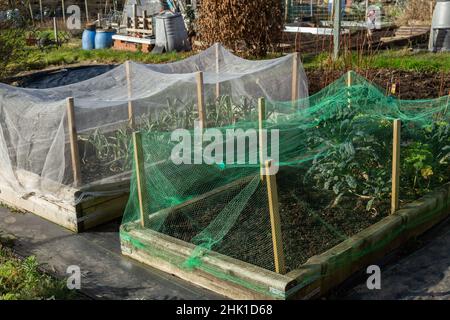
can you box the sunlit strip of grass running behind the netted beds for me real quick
[6,34,450,75]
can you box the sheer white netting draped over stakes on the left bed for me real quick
[0,44,308,202]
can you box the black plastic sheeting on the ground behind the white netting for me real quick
[15,65,116,89]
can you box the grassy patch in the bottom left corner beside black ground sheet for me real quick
[0,245,78,300]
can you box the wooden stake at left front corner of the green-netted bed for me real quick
[133,132,148,228]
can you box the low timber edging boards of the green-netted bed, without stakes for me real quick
[120,180,450,299]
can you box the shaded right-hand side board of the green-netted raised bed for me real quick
[287,184,450,299]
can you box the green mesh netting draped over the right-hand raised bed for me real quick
[123,72,450,277]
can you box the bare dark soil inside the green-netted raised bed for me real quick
[155,172,389,271]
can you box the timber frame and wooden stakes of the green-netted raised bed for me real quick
[120,113,450,299]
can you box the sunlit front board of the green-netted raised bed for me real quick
[121,227,293,300]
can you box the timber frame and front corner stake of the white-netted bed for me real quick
[0,98,131,232]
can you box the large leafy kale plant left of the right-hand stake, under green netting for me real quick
[304,107,392,210]
